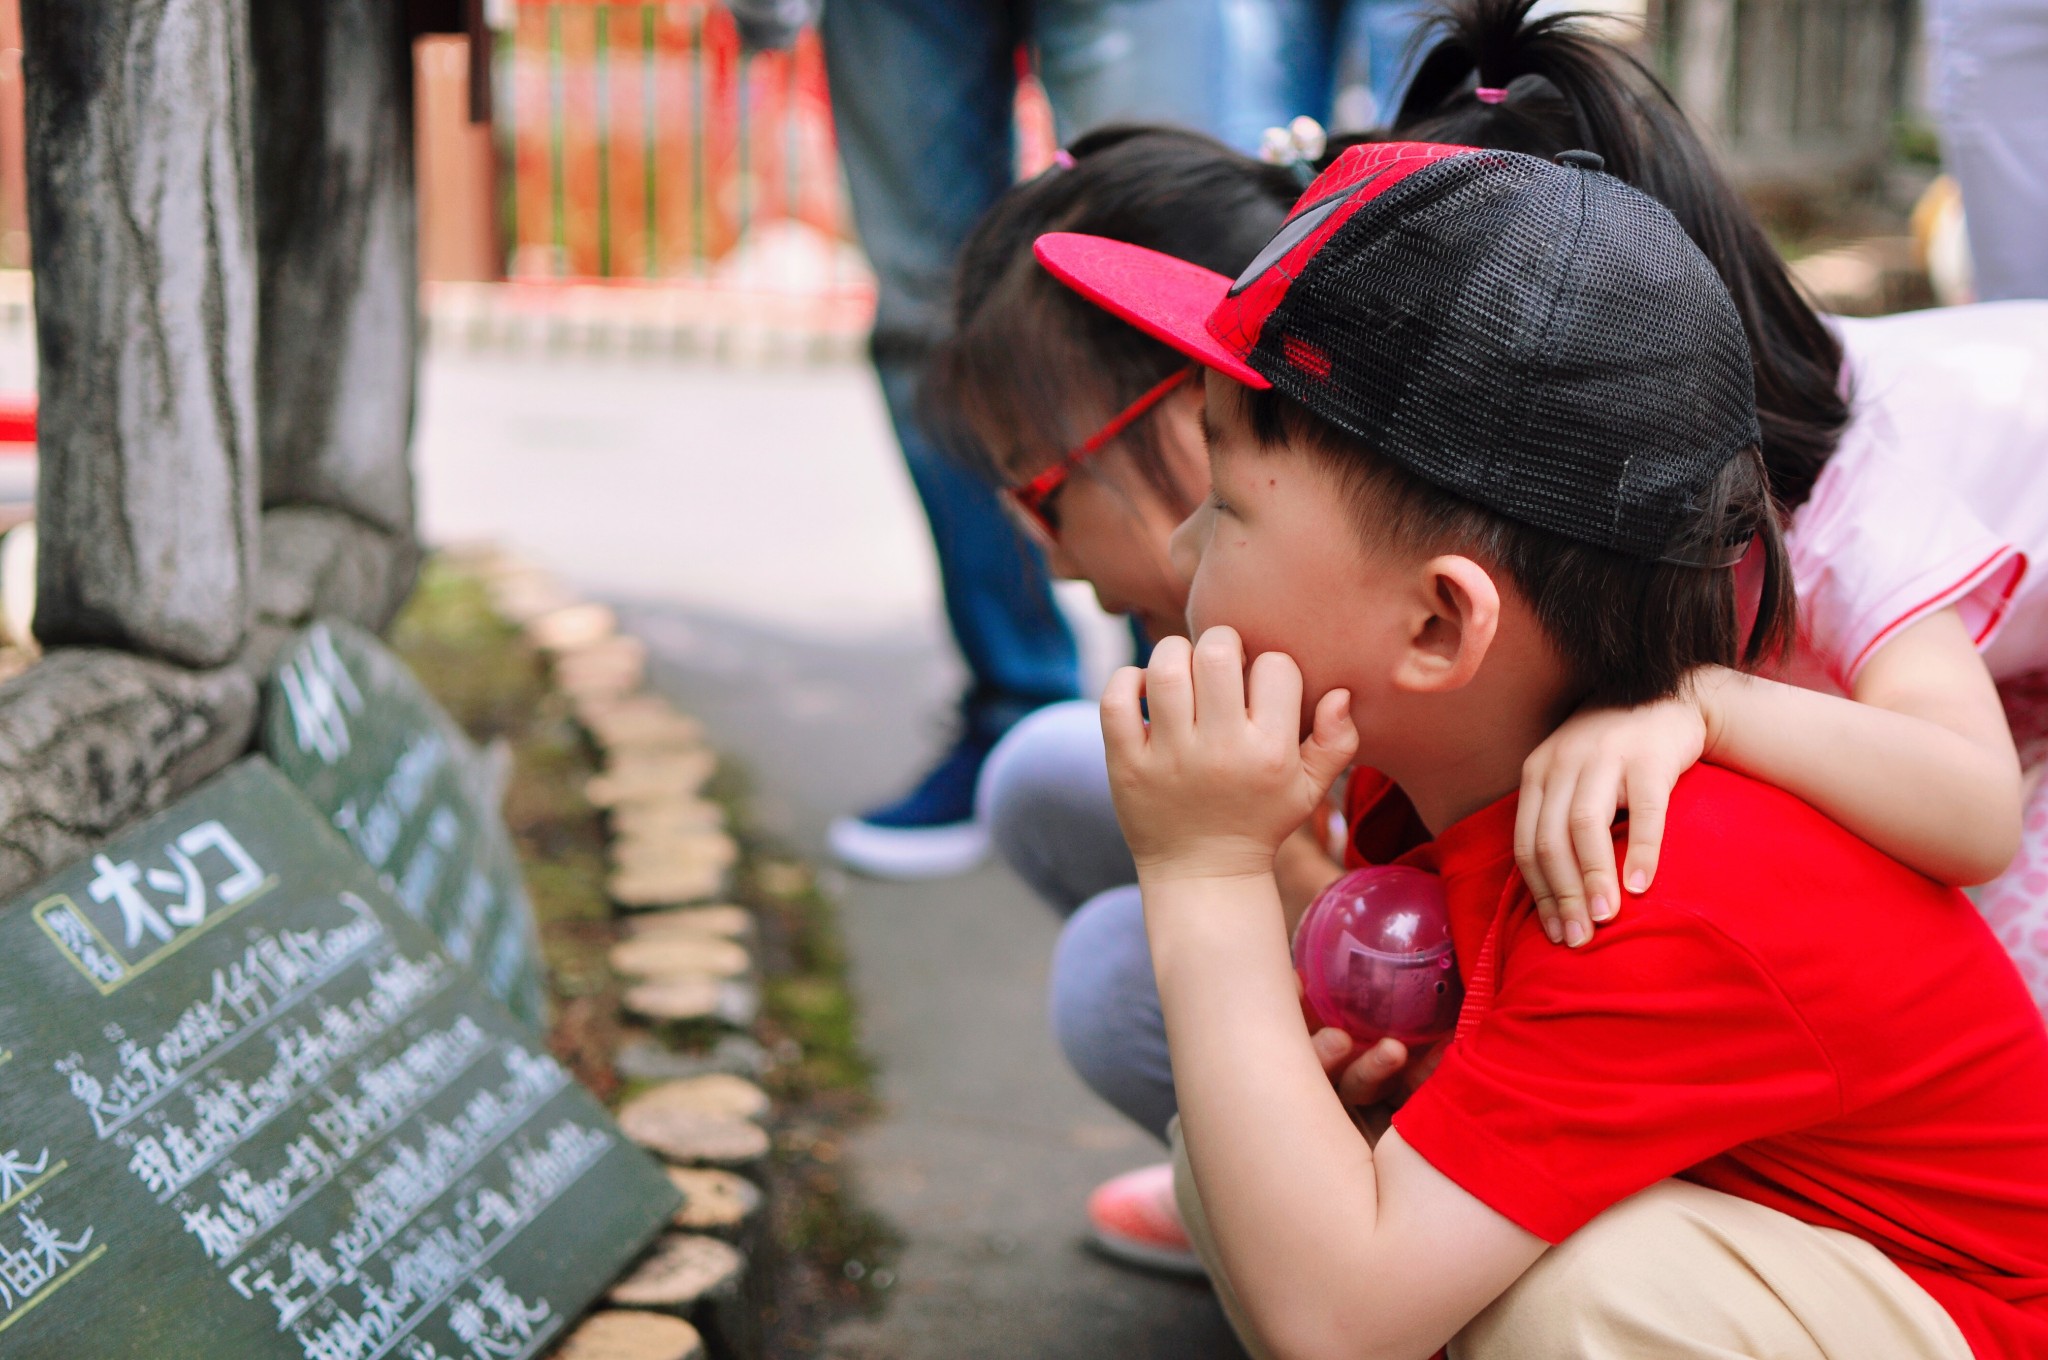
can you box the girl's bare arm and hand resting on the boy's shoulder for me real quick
[1516,608,2021,944]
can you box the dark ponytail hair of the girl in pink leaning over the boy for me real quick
[1368,0,1849,514]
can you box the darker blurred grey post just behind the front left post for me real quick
[250,0,420,547]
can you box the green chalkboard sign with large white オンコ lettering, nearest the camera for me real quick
[0,758,678,1360]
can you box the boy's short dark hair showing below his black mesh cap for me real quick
[1245,378,1792,707]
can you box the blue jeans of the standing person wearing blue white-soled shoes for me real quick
[823,0,1284,729]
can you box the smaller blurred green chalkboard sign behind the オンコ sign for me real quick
[264,621,547,1026]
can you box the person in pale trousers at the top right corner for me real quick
[1927,0,2048,303]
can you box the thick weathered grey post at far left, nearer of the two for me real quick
[20,0,260,666]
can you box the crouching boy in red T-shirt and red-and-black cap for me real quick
[1038,143,2048,1360]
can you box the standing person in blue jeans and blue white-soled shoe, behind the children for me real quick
[815,0,1407,879]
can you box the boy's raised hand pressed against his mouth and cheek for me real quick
[1102,627,1358,881]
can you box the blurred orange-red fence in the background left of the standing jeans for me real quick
[498,0,860,287]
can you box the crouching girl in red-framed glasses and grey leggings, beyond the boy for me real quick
[924,127,1337,1274]
